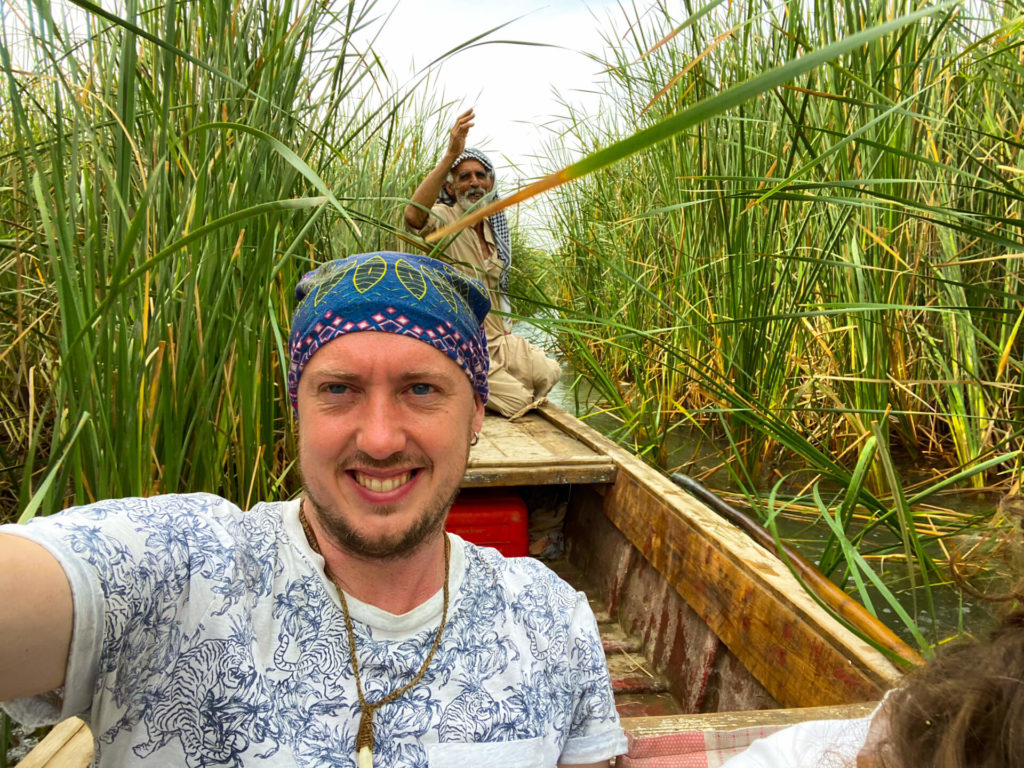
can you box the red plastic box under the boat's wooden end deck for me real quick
[444,488,529,557]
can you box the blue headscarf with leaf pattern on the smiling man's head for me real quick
[288,251,490,408]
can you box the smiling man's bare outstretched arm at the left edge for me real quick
[0,534,75,701]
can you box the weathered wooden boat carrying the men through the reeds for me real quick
[20,404,913,768]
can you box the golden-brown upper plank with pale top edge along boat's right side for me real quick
[542,407,900,707]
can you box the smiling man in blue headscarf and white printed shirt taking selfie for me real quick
[0,253,626,768]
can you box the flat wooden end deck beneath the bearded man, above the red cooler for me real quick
[462,412,615,487]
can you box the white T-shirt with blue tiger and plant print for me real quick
[0,494,626,768]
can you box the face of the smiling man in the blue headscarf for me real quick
[298,334,475,558]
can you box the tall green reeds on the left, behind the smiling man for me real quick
[0,0,446,518]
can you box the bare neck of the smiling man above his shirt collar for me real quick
[302,500,444,615]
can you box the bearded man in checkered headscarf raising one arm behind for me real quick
[404,110,561,416]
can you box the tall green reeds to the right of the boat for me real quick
[550,0,1024,647]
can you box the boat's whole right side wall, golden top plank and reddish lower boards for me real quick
[541,407,902,713]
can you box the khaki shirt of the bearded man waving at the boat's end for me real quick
[406,203,511,344]
